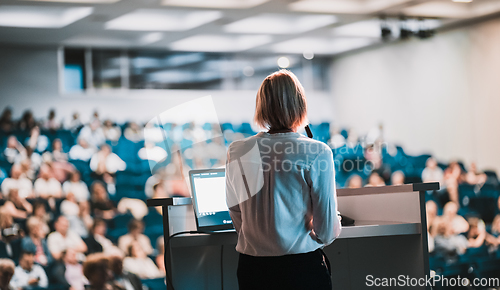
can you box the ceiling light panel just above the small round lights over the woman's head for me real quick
[271,37,378,55]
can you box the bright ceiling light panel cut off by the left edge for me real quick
[0,6,93,28]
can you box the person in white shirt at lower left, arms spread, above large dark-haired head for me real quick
[47,215,87,260]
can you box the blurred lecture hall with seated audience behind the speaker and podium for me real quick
[0,0,500,289]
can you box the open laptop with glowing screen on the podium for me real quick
[189,168,234,232]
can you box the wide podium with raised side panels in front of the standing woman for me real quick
[147,183,439,290]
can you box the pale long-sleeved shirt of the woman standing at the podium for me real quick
[226,132,341,256]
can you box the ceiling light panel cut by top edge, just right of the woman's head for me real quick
[288,0,409,14]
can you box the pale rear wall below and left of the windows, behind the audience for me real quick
[0,47,333,123]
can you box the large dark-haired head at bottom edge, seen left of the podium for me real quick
[83,253,111,290]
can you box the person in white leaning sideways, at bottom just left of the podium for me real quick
[123,241,163,279]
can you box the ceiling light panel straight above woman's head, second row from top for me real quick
[224,13,337,34]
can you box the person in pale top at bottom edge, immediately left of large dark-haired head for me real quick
[50,249,88,290]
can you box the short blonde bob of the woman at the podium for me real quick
[254,70,307,130]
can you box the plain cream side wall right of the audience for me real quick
[332,20,500,170]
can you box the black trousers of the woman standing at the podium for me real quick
[237,249,332,290]
